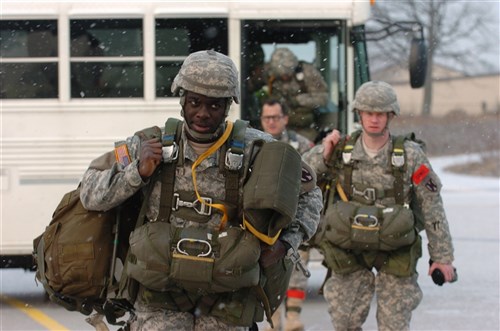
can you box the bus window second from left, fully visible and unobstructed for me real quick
[70,19,144,98]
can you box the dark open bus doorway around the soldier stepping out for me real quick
[241,20,346,138]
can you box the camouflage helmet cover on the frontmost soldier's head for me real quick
[172,50,240,103]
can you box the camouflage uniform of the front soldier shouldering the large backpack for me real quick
[81,50,322,330]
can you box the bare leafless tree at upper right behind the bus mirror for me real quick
[367,0,499,115]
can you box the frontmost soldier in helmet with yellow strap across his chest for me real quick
[81,51,322,331]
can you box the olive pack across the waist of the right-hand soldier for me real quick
[325,201,416,251]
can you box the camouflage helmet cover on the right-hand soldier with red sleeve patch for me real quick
[353,81,399,115]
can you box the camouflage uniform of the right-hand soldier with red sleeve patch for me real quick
[304,81,454,330]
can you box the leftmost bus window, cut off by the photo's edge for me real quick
[0,20,58,99]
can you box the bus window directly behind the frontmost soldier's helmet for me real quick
[155,18,228,98]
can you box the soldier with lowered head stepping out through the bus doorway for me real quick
[267,48,328,141]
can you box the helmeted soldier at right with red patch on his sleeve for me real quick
[304,81,456,330]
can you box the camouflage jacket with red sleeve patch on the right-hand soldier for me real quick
[303,135,454,263]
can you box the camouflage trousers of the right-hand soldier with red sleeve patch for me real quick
[323,269,422,331]
